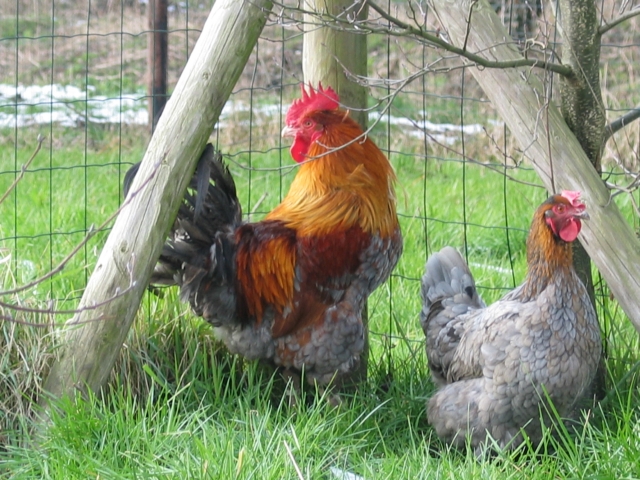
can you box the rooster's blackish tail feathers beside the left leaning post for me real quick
[124,144,242,300]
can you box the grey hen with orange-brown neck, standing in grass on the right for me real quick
[420,191,601,452]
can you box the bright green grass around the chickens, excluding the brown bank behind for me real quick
[0,119,640,479]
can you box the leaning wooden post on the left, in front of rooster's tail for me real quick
[44,0,272,403]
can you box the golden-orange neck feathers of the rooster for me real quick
[267,110,397,237]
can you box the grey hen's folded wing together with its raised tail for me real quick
[421,247,540,385]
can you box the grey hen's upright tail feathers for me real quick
[422,247,484,321]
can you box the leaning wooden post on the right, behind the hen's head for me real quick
[432,0,640,338]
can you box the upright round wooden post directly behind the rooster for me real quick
[302,0,369,383]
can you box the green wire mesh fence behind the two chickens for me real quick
[0,0,640,394]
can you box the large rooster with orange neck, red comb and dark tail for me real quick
[125,85,402,386]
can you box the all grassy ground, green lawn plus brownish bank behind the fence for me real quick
[0,2,640,472]
